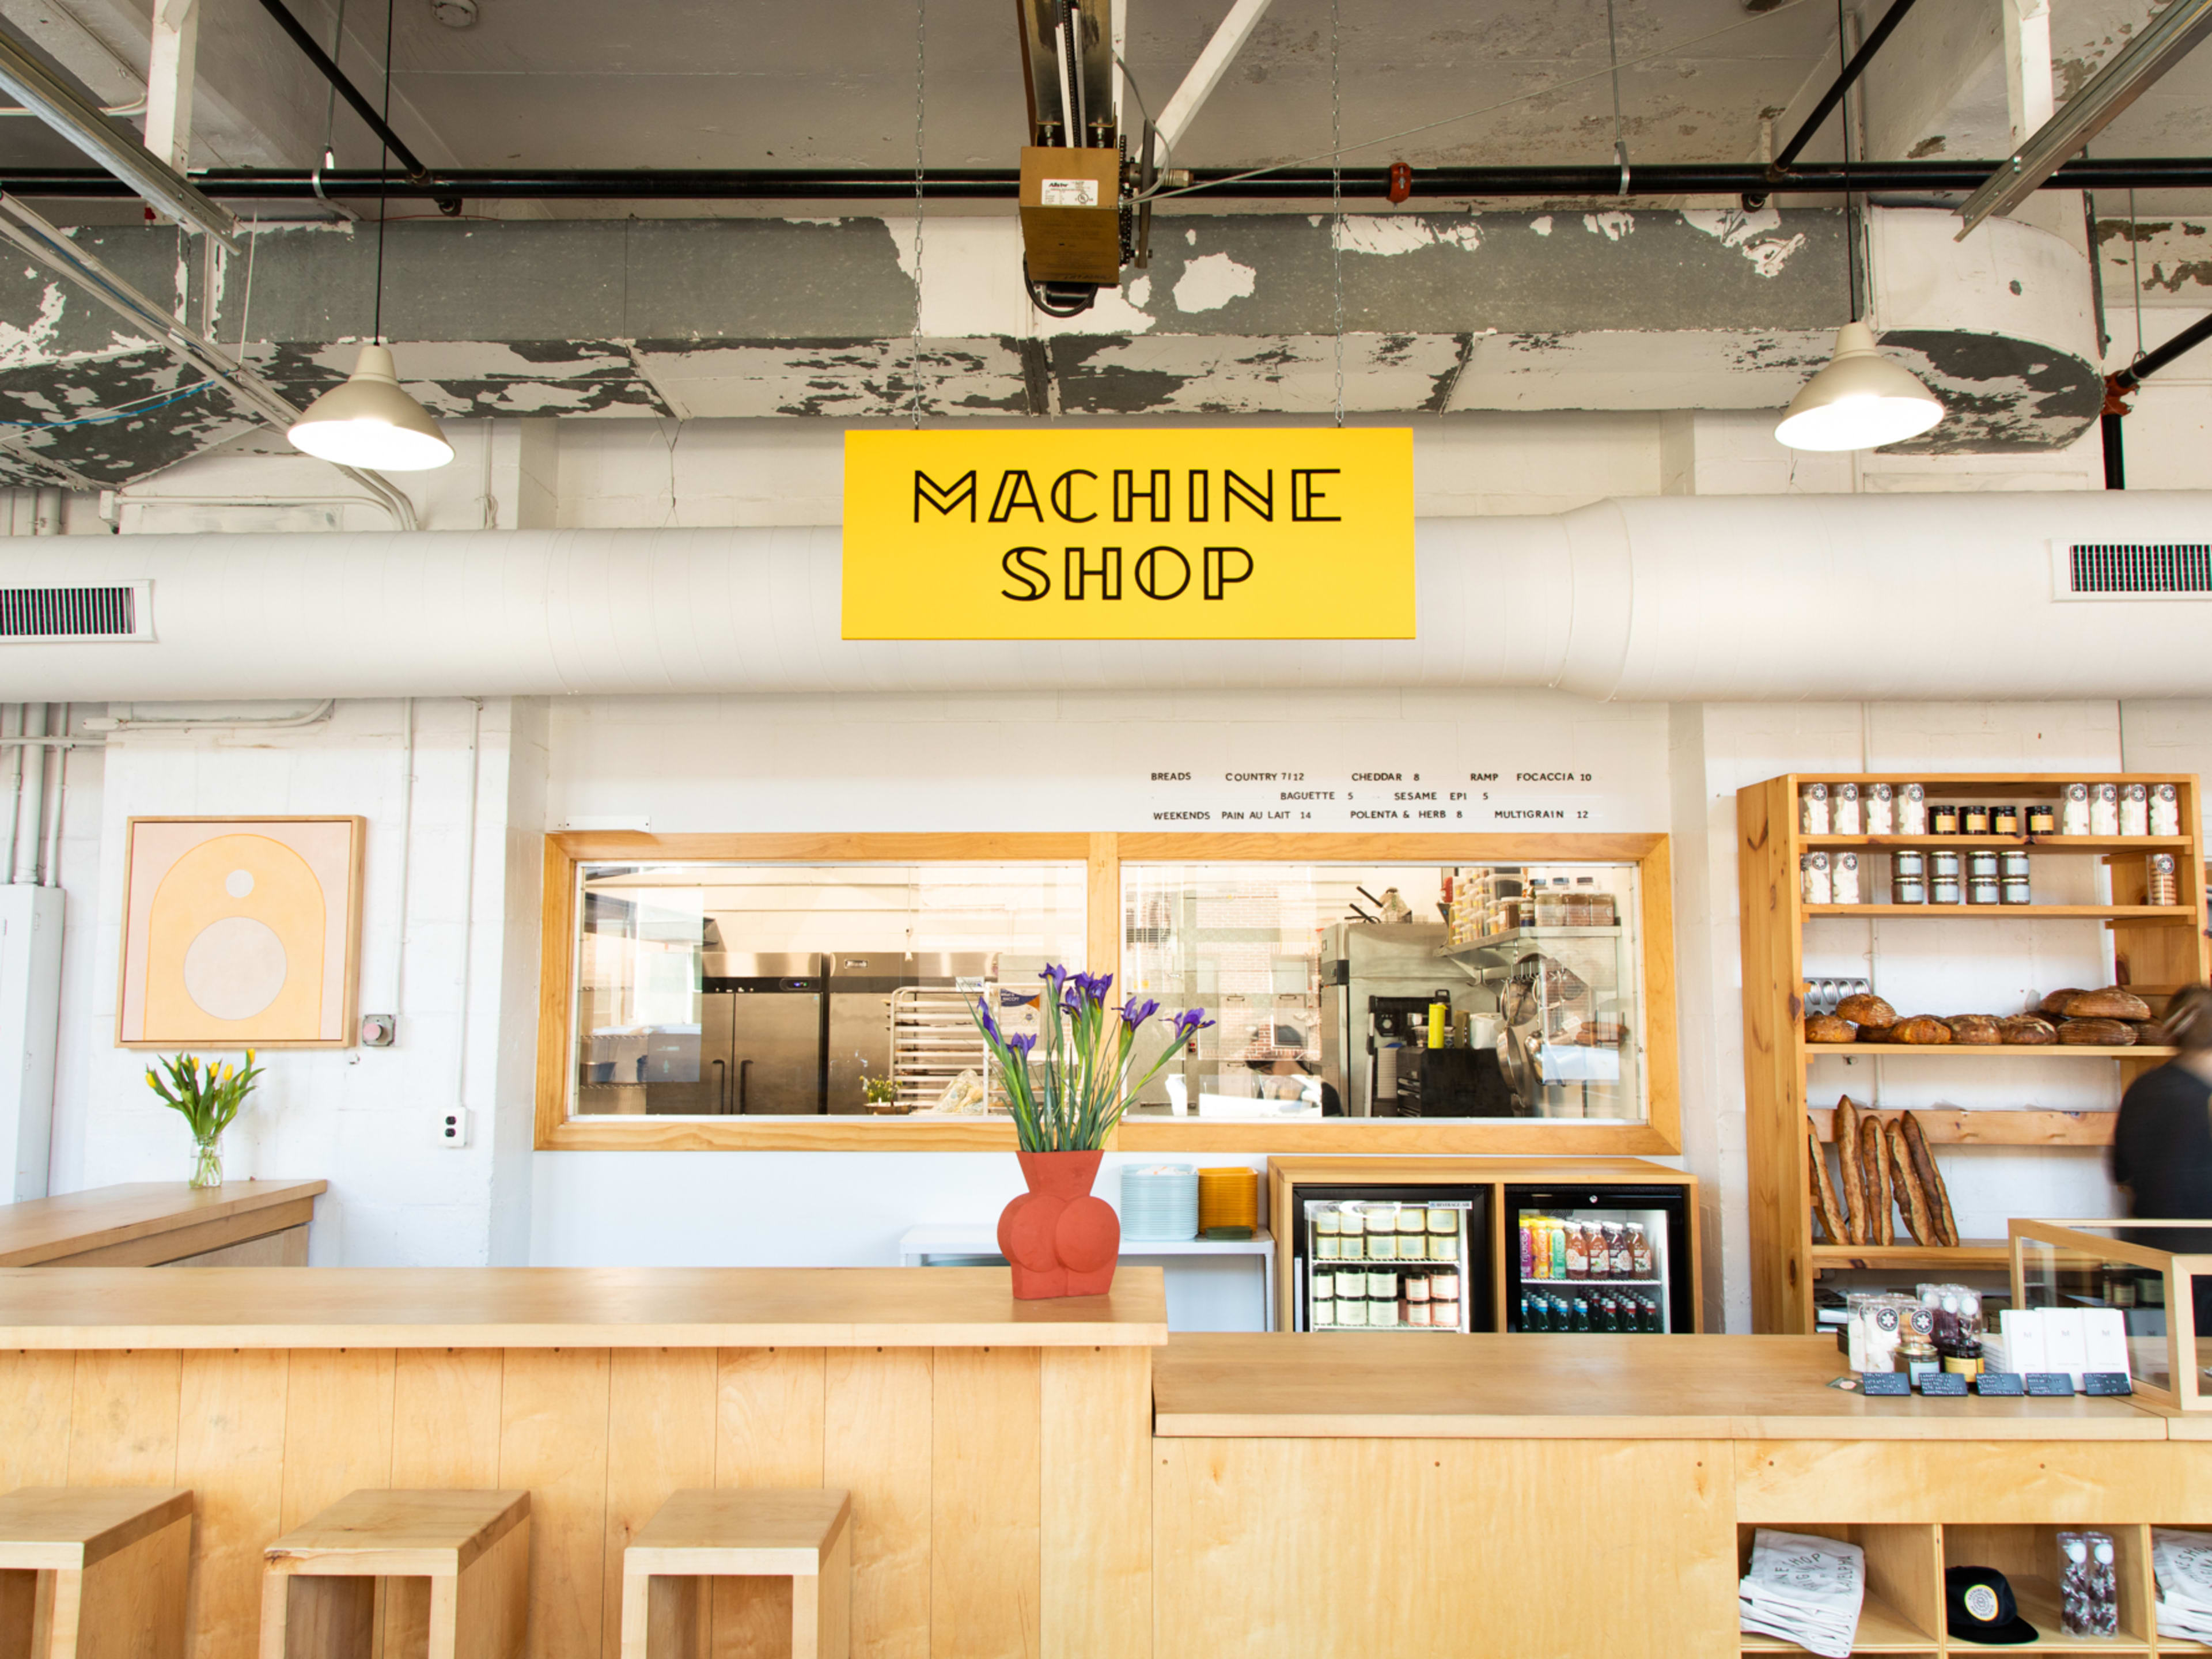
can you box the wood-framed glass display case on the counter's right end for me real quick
[2011,1219,2212,1411]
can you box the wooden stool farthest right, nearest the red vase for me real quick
[622,1488,851,1659]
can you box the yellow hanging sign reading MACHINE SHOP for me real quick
[845,427,1414,639]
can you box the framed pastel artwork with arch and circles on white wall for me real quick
[115,819,367,1048]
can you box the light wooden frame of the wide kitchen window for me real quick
[535,830,1681,1157]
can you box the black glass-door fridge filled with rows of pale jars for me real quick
[1292,1185,1495,1332]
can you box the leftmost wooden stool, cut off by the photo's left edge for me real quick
[0,1486,192,1659]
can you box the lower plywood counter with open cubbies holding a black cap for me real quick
[1153,1332,2212,1659]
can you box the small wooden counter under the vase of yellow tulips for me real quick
[0,1181,329,1267]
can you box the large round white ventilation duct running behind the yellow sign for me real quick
[13,491,2212,701]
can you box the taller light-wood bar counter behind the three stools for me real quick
[0,1267,1166,1659]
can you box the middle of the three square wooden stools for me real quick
[261,1491,531,1659]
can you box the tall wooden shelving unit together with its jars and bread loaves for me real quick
[1736,772,2207,1332]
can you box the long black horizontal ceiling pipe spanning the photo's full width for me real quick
[0,157,2212,208]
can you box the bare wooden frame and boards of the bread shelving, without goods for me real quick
[1736,772,2205,1334]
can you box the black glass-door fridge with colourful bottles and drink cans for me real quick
[1504,1185,1696,1332]
